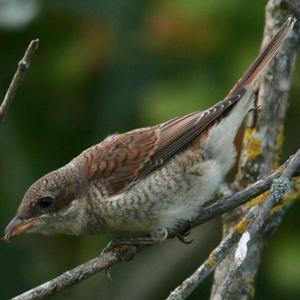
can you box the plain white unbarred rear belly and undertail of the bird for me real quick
[150,89,252,228]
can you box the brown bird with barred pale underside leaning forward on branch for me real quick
[4,18,296,245]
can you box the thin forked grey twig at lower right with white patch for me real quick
[167,149,300,300]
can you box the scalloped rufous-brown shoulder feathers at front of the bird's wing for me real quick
[80,128,159,195]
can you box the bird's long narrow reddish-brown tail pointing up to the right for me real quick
[226,17,296,98]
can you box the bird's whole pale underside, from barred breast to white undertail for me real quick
[63,86,255,232]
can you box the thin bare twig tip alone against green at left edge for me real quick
[0,39,39,123]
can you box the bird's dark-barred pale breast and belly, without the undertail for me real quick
[94,148,223,232]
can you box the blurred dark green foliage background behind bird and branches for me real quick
[0,0,300,300]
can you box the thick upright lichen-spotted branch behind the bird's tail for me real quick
[211,0,300,300]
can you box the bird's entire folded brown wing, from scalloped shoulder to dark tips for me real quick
[82,88,246,195]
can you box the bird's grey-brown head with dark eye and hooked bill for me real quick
[4,167,82,241]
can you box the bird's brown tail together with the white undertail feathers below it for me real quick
[206,18,296,169]
